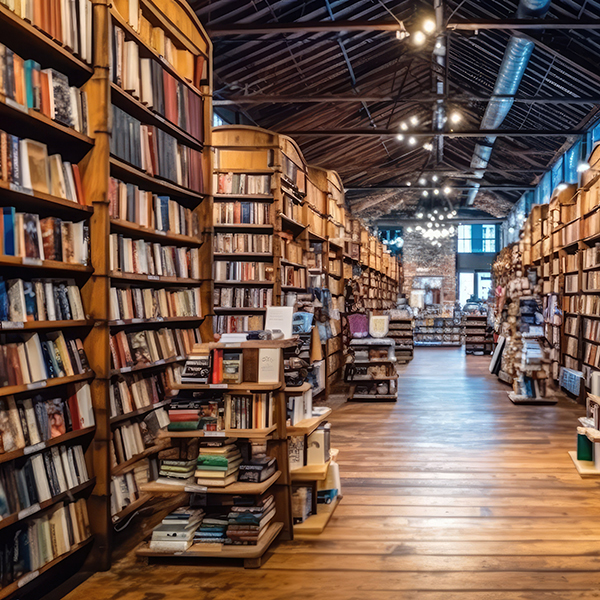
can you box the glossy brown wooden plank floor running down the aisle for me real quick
[67,349,600,600]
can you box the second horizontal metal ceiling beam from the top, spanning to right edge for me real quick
[213,94,600,106]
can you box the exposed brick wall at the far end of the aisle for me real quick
[402,229,456,303]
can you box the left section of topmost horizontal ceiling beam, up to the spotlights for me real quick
[206,20,400,38]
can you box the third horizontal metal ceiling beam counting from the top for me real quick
[277,128,585,138]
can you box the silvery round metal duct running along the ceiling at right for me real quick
[467,0,552,205]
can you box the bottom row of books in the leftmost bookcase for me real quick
[0,498,91,587]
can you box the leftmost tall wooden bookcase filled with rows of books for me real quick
[0,2,97,598]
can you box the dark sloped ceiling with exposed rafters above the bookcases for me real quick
[190,0,600,220]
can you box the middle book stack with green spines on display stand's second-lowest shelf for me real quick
[196,438,242,487]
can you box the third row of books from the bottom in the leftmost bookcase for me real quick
[0,384,94,454]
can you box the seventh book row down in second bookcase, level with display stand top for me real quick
[110,328,201,370]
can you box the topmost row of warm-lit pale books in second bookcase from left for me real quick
[113,0,208,88]
